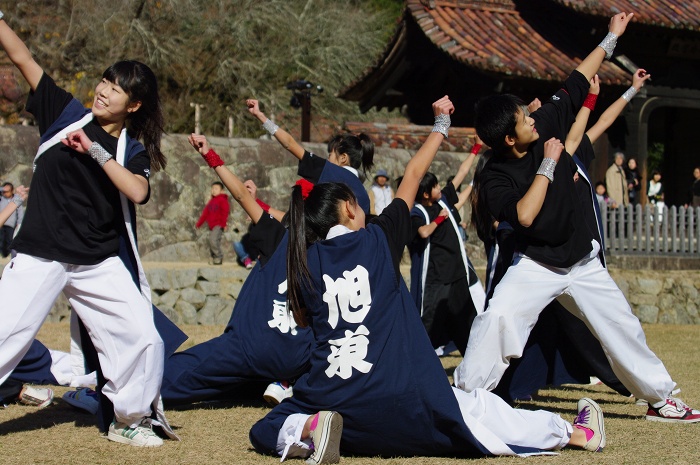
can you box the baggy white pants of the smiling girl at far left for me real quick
[0,254,163,426]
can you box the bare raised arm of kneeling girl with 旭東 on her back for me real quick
[396,95,454,210]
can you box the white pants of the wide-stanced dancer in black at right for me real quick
[454,250,675,404]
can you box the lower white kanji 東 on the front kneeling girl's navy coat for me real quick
[326,325,372,379]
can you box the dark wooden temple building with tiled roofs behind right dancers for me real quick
[339,0,700,205]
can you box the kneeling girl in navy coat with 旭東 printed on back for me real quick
[250,96,605,464]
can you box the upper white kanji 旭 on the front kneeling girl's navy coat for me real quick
[323,265,372,328]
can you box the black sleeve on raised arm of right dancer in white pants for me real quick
[531,70,590,143]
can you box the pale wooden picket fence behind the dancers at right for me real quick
[600,203,700,257]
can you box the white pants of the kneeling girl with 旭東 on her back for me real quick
[277,388,573,460]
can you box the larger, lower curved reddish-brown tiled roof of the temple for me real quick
[407,0,629,84]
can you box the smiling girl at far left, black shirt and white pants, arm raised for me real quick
[0,12,174,447]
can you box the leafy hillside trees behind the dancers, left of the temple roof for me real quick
[5,0,403,136]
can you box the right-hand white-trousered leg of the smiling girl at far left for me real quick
[64,257,163,427]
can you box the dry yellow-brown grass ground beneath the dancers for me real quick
[0,323,700,465]
